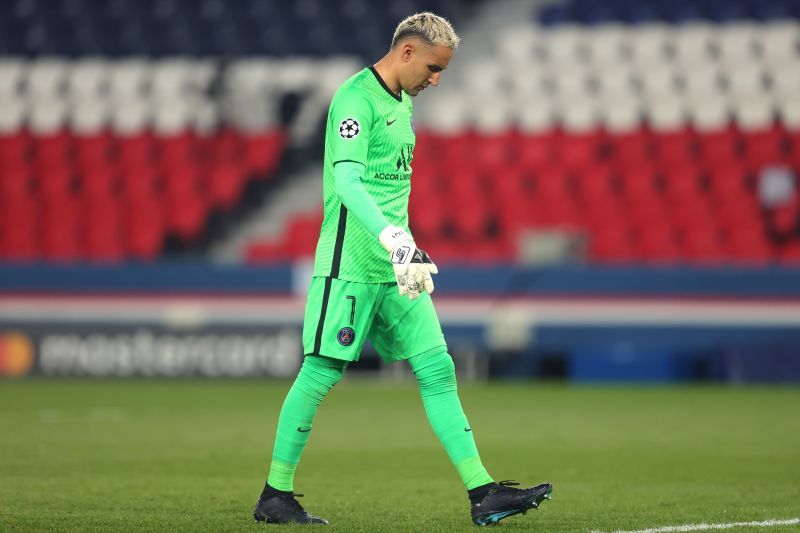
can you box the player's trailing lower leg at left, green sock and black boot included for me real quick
[253,356,347,524]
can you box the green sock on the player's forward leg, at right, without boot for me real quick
[408,348,494,490]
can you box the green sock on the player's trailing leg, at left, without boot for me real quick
[267,356,347,491]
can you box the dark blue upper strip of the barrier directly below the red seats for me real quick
[0,263,800,299]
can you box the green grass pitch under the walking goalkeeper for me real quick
[0,379,800,533]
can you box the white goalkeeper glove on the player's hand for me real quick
[379,226,439,300]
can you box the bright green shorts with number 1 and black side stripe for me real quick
[303,277,447,361]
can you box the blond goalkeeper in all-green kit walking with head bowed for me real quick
[253,13,551,525]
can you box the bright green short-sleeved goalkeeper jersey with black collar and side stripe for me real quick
[314,67,415,283]
